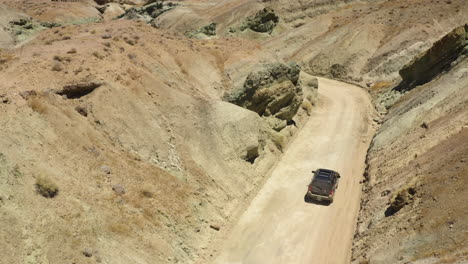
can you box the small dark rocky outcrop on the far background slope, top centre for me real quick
[240,8,279,33]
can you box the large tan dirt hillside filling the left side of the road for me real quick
[0,9,317,263]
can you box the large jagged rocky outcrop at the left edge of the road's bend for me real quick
[224,63,303,121]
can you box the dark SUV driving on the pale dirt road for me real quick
[306,169,340,203]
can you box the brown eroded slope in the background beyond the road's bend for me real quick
[157,0,468,86]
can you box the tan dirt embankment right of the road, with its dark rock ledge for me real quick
[353,25,468,263]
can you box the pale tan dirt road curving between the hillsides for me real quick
[214,78,373,264]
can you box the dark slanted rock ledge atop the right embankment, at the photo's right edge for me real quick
[399,24,468,90]
